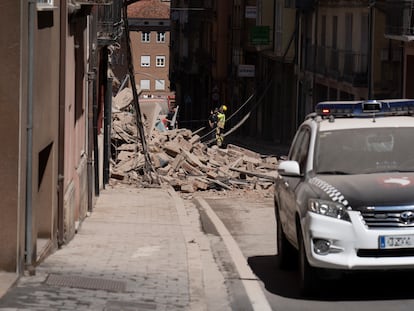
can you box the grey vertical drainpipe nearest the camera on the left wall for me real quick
[25,0,36,274]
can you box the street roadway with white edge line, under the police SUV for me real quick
[193,193,414,311]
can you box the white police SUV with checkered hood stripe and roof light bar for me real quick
[274,99,414,294]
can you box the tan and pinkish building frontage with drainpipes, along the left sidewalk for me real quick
[0,0,122,277]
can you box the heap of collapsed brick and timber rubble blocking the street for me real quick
[111,88,277,193]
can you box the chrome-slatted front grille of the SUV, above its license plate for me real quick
[361,205,414,228]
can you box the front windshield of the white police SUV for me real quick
[315,128,414,174]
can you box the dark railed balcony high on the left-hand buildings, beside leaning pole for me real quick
[97,0,123,46]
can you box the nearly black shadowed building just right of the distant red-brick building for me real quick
[170,0,233,130]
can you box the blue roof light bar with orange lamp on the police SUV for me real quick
[315,99,414,118]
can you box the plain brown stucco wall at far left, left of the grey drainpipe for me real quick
[0,0,27,271]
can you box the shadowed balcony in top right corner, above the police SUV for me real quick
[377,0,414,42]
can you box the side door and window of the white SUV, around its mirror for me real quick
[278,126,311,244]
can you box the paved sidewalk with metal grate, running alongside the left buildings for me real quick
[0,185,207,311]
